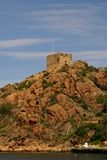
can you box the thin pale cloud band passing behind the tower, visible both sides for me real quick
[0,50,107,61]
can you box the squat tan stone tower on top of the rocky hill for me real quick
[47,52,72,67]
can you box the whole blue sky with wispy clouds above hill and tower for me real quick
[0,0,107,86]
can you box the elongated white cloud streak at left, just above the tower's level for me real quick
[0,38,58,49]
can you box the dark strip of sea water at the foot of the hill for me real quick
[0,152,107,160]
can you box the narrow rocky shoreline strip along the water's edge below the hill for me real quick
[0,145,107,153]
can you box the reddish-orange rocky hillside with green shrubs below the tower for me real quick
[0,61,107,150]
